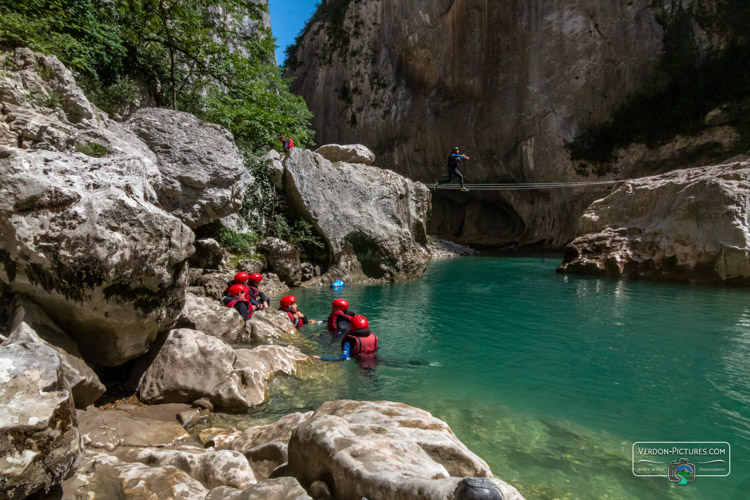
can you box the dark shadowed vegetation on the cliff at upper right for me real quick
[568,0,750,174]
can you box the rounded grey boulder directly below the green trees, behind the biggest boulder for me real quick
[126,108,253,228]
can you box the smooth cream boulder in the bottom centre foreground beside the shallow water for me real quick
[287,401,523,500]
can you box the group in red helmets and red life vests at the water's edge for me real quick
[222,272,378,361]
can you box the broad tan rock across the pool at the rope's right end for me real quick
[559,161,750,285]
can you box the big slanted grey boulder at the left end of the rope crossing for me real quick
[284,148,430,282]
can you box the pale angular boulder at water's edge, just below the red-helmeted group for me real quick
[138,329,307,411]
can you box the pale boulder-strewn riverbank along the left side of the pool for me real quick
[0,49,521,500]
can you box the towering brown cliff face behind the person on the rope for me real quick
[287,0,663,248]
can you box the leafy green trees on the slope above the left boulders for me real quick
[0,0,313,151]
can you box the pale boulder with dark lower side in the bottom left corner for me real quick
[0,343,82,499]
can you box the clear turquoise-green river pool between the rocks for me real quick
[228,256,750,499]
